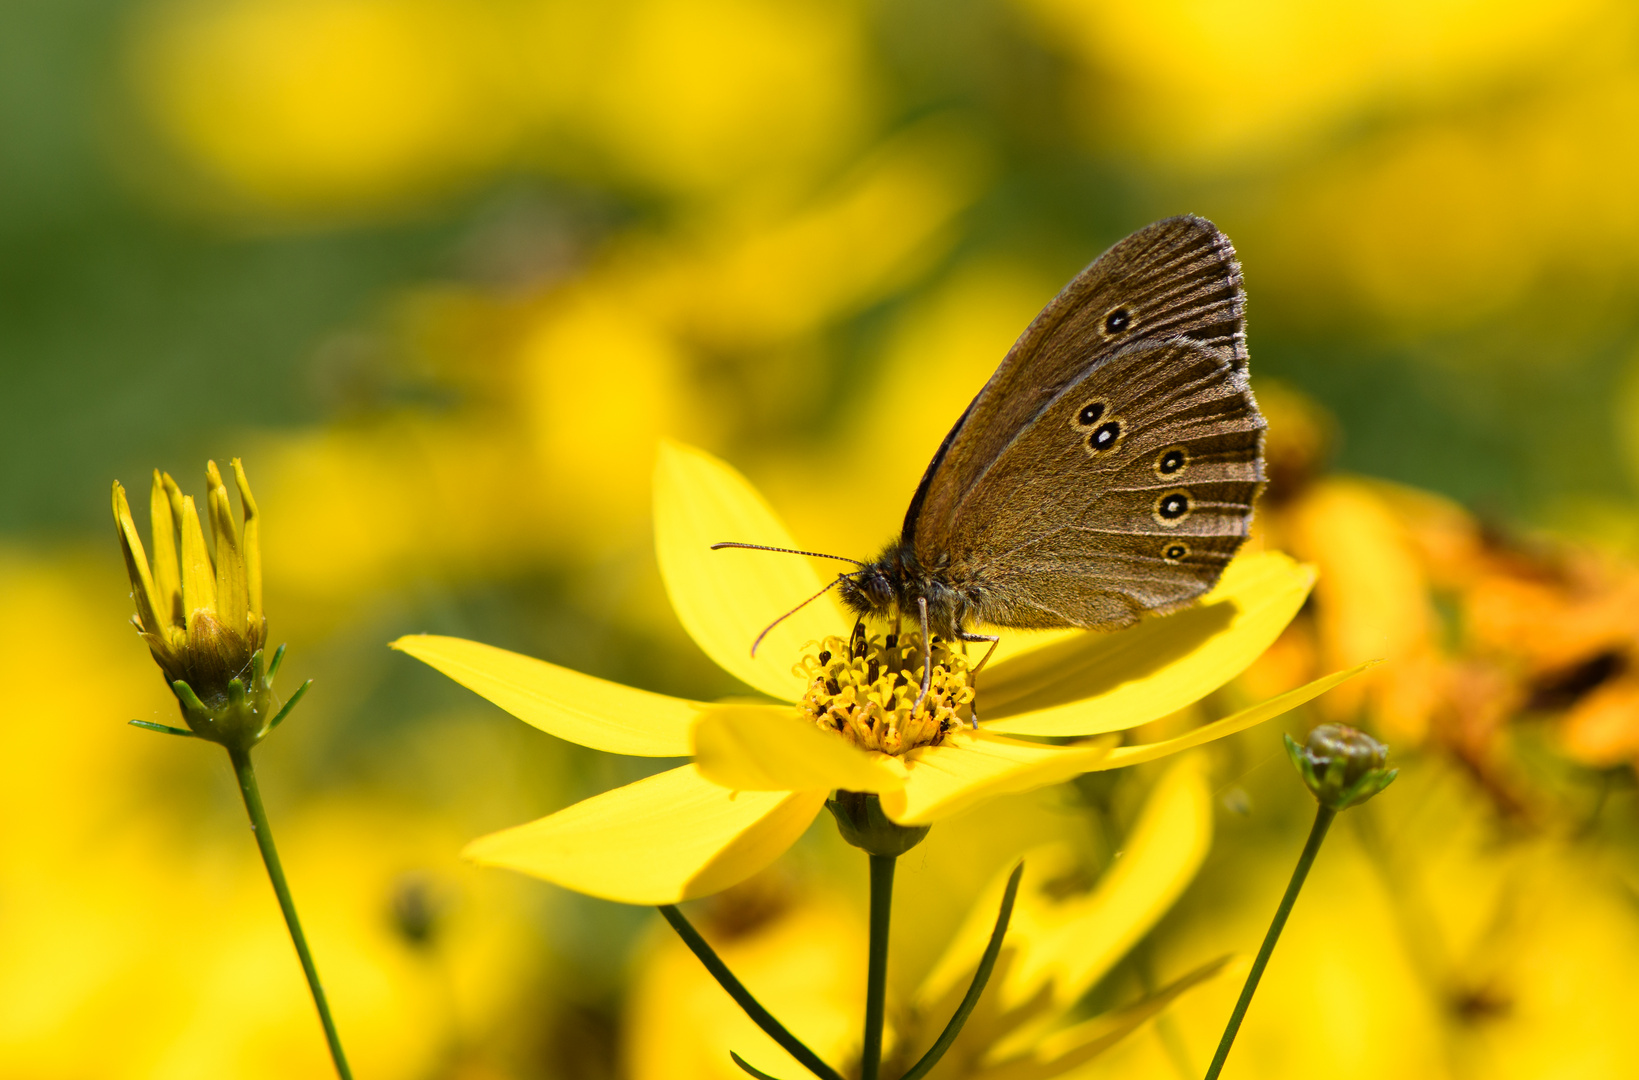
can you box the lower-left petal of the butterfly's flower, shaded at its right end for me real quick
[465,765,826,903]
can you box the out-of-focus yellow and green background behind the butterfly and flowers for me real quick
[9,0,1639,1080]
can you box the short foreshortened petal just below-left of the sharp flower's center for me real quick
[693,705,905,792]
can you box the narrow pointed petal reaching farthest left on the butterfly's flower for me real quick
[392,634,705,757]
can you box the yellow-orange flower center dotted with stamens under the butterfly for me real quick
[798,624,974,756]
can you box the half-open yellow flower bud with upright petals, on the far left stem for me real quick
[113,457,277,742]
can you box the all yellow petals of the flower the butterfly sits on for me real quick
[393,444,1354,905]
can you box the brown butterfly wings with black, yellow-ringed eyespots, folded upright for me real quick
[905,218,1264,626]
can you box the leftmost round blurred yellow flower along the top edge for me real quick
[134,0,523,215]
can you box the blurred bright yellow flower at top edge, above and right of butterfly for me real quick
[1018,0,1614,164]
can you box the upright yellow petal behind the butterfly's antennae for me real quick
[654,442,844,701]
